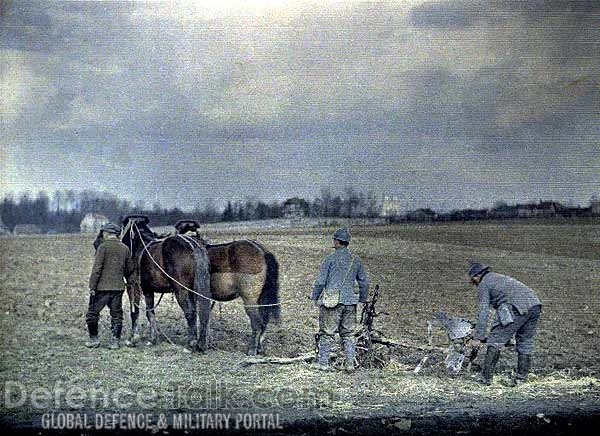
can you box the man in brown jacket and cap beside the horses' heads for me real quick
[85,223,134,350]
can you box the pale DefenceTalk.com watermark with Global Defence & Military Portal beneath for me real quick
[0,378,337,430]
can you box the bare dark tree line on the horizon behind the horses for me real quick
[0,186,379,232]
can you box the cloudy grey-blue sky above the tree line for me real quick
[0,0,600,210]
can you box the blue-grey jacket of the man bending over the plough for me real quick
[473,272,541,340]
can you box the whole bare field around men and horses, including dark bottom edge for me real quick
[0,223,600,435]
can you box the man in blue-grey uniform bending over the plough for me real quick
[468,263,542,385]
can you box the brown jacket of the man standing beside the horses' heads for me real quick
[89,239,134,291]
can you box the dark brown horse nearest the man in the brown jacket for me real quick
[121,216,210,351]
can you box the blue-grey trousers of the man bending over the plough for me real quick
[487,305,542,355]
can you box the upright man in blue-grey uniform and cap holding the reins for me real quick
[310,229,369,372]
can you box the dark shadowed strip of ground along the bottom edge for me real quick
[2,398,600,436]
